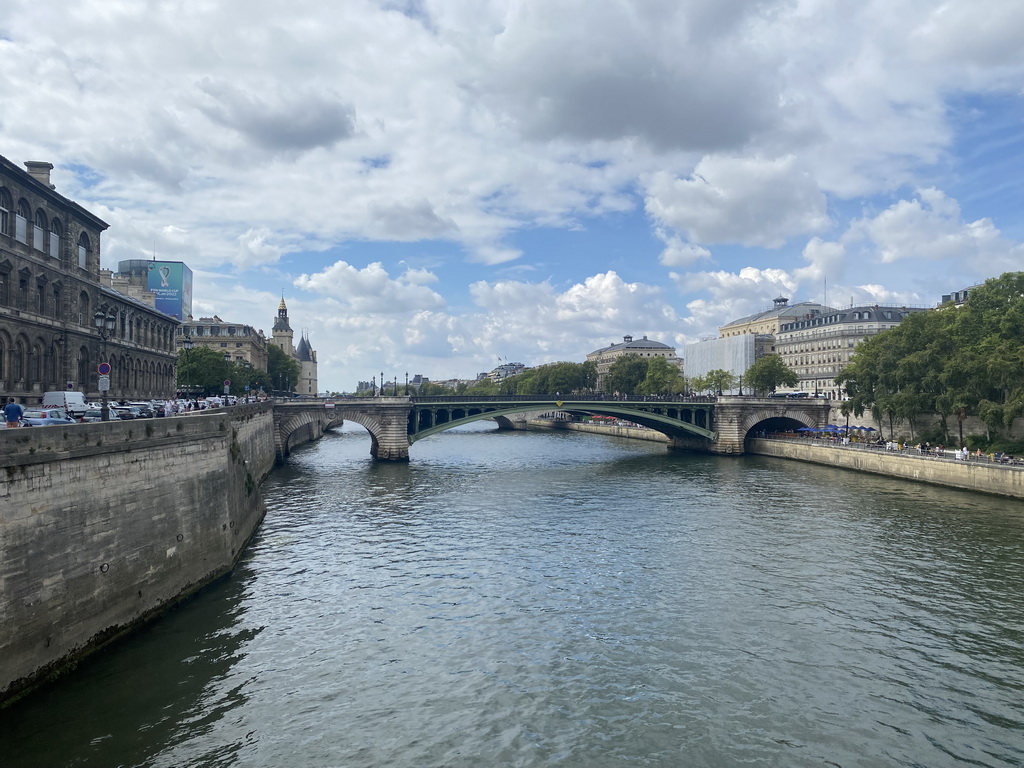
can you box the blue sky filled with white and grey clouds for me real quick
[0,0,1024,391]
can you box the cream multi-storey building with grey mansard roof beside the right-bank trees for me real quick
[775,304,928,398]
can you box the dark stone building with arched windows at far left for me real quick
[0,156,177,406]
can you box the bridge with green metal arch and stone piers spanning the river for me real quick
[274,395,829,461]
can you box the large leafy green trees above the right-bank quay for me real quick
[836,272,1024,444]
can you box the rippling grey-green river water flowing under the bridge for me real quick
[0,425,1024,768]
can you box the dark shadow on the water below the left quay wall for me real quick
[0,563,259,768]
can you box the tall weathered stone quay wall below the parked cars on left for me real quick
[0,406,274,703]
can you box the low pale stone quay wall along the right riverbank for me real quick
[746,438,1024,499]
